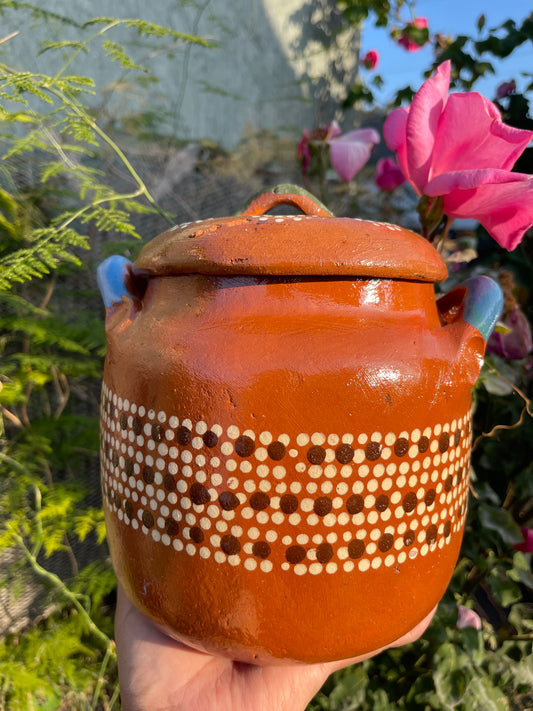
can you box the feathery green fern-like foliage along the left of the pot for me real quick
[0,0,208,711]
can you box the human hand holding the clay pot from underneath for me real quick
[115,585,435,711]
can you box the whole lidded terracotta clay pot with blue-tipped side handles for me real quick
[99,193,501,663]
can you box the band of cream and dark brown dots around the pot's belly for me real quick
[101,384,471,575]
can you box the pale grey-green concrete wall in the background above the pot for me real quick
[0,0,359,148]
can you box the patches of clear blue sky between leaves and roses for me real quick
[362,0,533,103]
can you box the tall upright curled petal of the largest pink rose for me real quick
[406,61,451,194]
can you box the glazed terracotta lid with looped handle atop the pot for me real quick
[134,192,448,282]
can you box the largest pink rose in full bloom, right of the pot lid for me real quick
[383,61,533,250]
